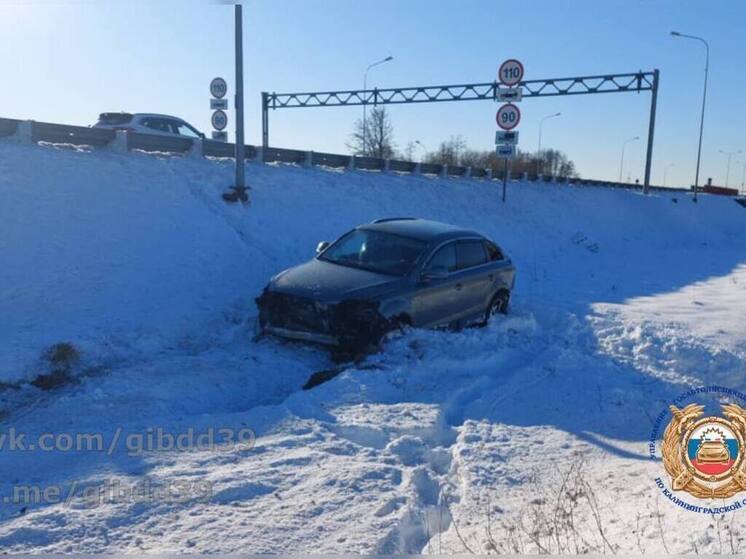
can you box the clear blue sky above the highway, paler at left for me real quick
[0,0,746,186]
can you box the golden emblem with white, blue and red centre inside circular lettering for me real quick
[661,404,746,499]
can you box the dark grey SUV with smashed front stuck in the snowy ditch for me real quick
[256,218,515,349]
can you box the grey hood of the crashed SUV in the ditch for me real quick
[269,259,402,302]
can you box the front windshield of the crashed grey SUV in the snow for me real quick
[319,229,426,276]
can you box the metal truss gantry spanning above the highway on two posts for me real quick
[262,70,660,193]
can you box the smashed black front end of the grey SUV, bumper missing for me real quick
[256,289,389,348]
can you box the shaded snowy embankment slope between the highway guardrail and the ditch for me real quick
[0,143,746,382]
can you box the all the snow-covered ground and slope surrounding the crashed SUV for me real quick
[0,143,746,553]
